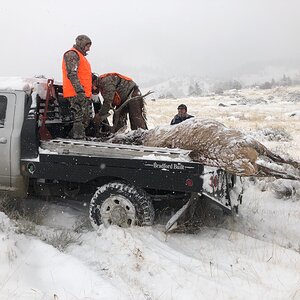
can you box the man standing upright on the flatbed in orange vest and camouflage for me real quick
[62,34,92,139]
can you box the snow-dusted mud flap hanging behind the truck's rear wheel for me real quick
[165,193,199,233]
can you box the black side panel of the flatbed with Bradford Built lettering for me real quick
[23,155,203,192]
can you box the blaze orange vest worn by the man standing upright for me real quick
[62,48,92,98]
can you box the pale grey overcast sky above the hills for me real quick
[0,0,300,84]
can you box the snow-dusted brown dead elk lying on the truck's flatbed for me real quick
[111,118,300,180]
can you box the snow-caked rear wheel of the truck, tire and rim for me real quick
[90,182,154,229]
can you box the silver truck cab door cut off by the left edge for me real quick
[0,93,16,190]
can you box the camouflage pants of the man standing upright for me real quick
[69,94,92,139]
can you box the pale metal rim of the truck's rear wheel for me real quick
[98,195,136,228]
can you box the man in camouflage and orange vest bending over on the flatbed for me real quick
[93,73,148,132]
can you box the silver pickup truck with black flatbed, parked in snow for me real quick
[0,78,241,228]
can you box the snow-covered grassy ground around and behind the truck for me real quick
[0,87,300,300]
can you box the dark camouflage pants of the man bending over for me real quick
[115,87,148,131]
